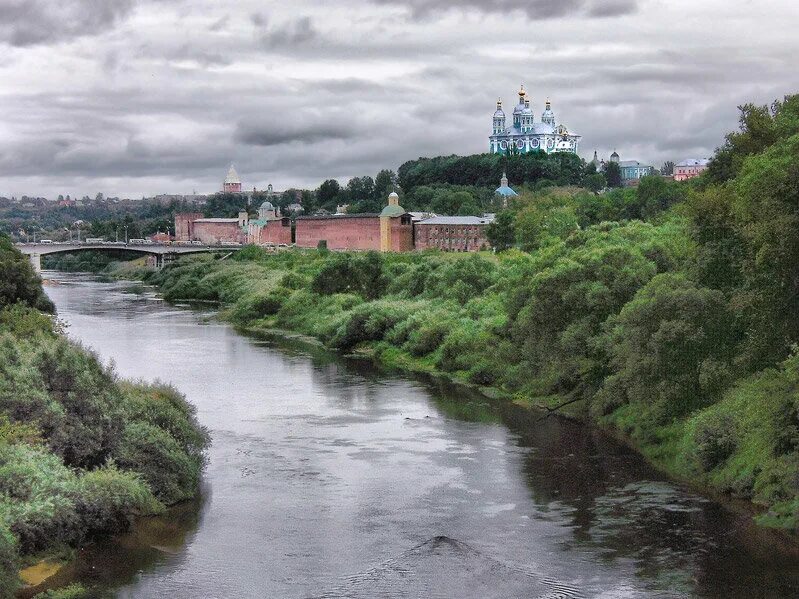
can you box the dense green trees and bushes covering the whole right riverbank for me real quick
[131,96,799,530]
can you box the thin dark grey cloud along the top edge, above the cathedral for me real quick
[372,0,639,20]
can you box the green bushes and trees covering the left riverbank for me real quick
[0,237,208,598]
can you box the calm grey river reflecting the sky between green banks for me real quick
[39,273,799,599]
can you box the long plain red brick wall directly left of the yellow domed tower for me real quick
[295,216,382,251]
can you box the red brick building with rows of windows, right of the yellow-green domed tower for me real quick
[414,216,492,252]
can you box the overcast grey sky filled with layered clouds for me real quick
[0,0,799,197]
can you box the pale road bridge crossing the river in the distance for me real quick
[16,241,242,272]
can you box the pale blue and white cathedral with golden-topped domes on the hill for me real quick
[489,85,582,154]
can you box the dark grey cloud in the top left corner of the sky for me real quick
[0,0,134,46]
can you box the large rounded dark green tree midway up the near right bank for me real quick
[599,273,734,424]
